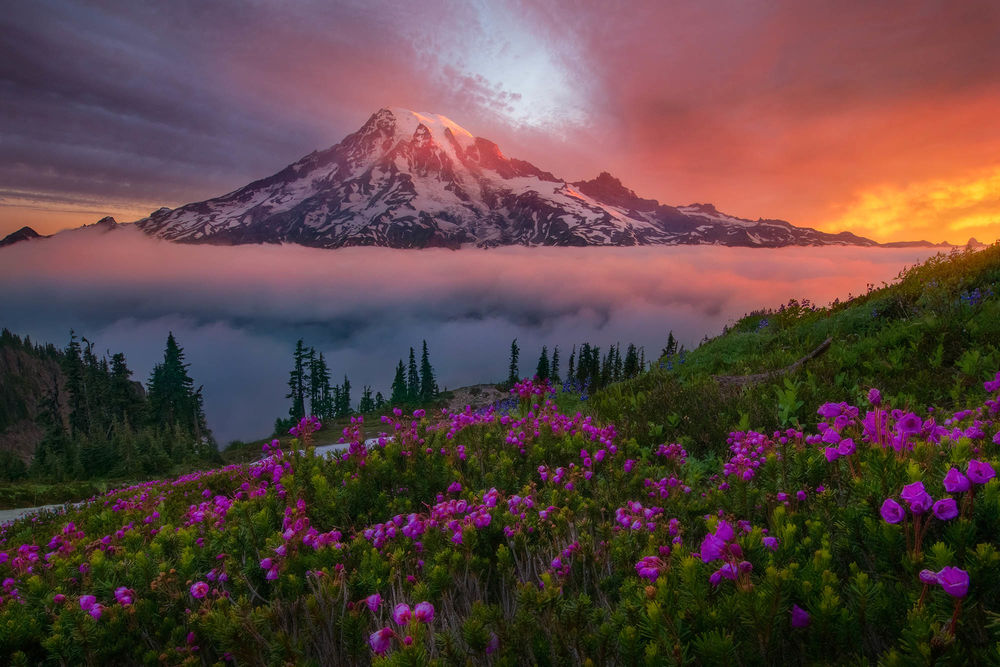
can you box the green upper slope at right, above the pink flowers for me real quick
[591,244,1000,454]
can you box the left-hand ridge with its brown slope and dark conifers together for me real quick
[0,329,216,481]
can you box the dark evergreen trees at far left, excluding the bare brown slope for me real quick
[0,330,218,481]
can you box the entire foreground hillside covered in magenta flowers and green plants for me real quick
[0,246,1000,665]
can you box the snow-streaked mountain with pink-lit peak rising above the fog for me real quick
[136,109,878,248]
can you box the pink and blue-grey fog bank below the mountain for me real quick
[0,228,931,442]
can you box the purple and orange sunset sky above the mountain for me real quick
[0,0,1000,243]
